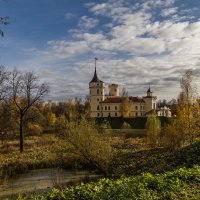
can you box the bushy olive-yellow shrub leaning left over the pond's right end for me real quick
[66,118,112,176]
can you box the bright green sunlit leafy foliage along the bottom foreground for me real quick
[18,166,200,200]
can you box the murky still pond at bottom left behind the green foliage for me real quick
[0,169,100,199]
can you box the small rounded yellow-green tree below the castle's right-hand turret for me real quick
[145,115,161,147]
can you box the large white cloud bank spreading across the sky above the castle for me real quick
[20,0,200,98]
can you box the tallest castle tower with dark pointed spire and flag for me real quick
[89,58,105,117]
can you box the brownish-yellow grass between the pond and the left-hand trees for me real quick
[0,135,84,183]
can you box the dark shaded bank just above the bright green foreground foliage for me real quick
[110,141,200,176]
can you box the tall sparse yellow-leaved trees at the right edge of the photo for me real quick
[165,69,200,148]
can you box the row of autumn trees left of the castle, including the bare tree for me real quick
[0,67,88,152]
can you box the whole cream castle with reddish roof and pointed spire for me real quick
[89,59,171,117]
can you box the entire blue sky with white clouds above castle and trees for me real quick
[0,0,200,101]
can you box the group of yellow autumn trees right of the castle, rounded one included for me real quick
[146,70,200,149]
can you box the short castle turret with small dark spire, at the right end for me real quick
[144,86,157,113]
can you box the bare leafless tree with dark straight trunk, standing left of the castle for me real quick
[10,70,49,152]
